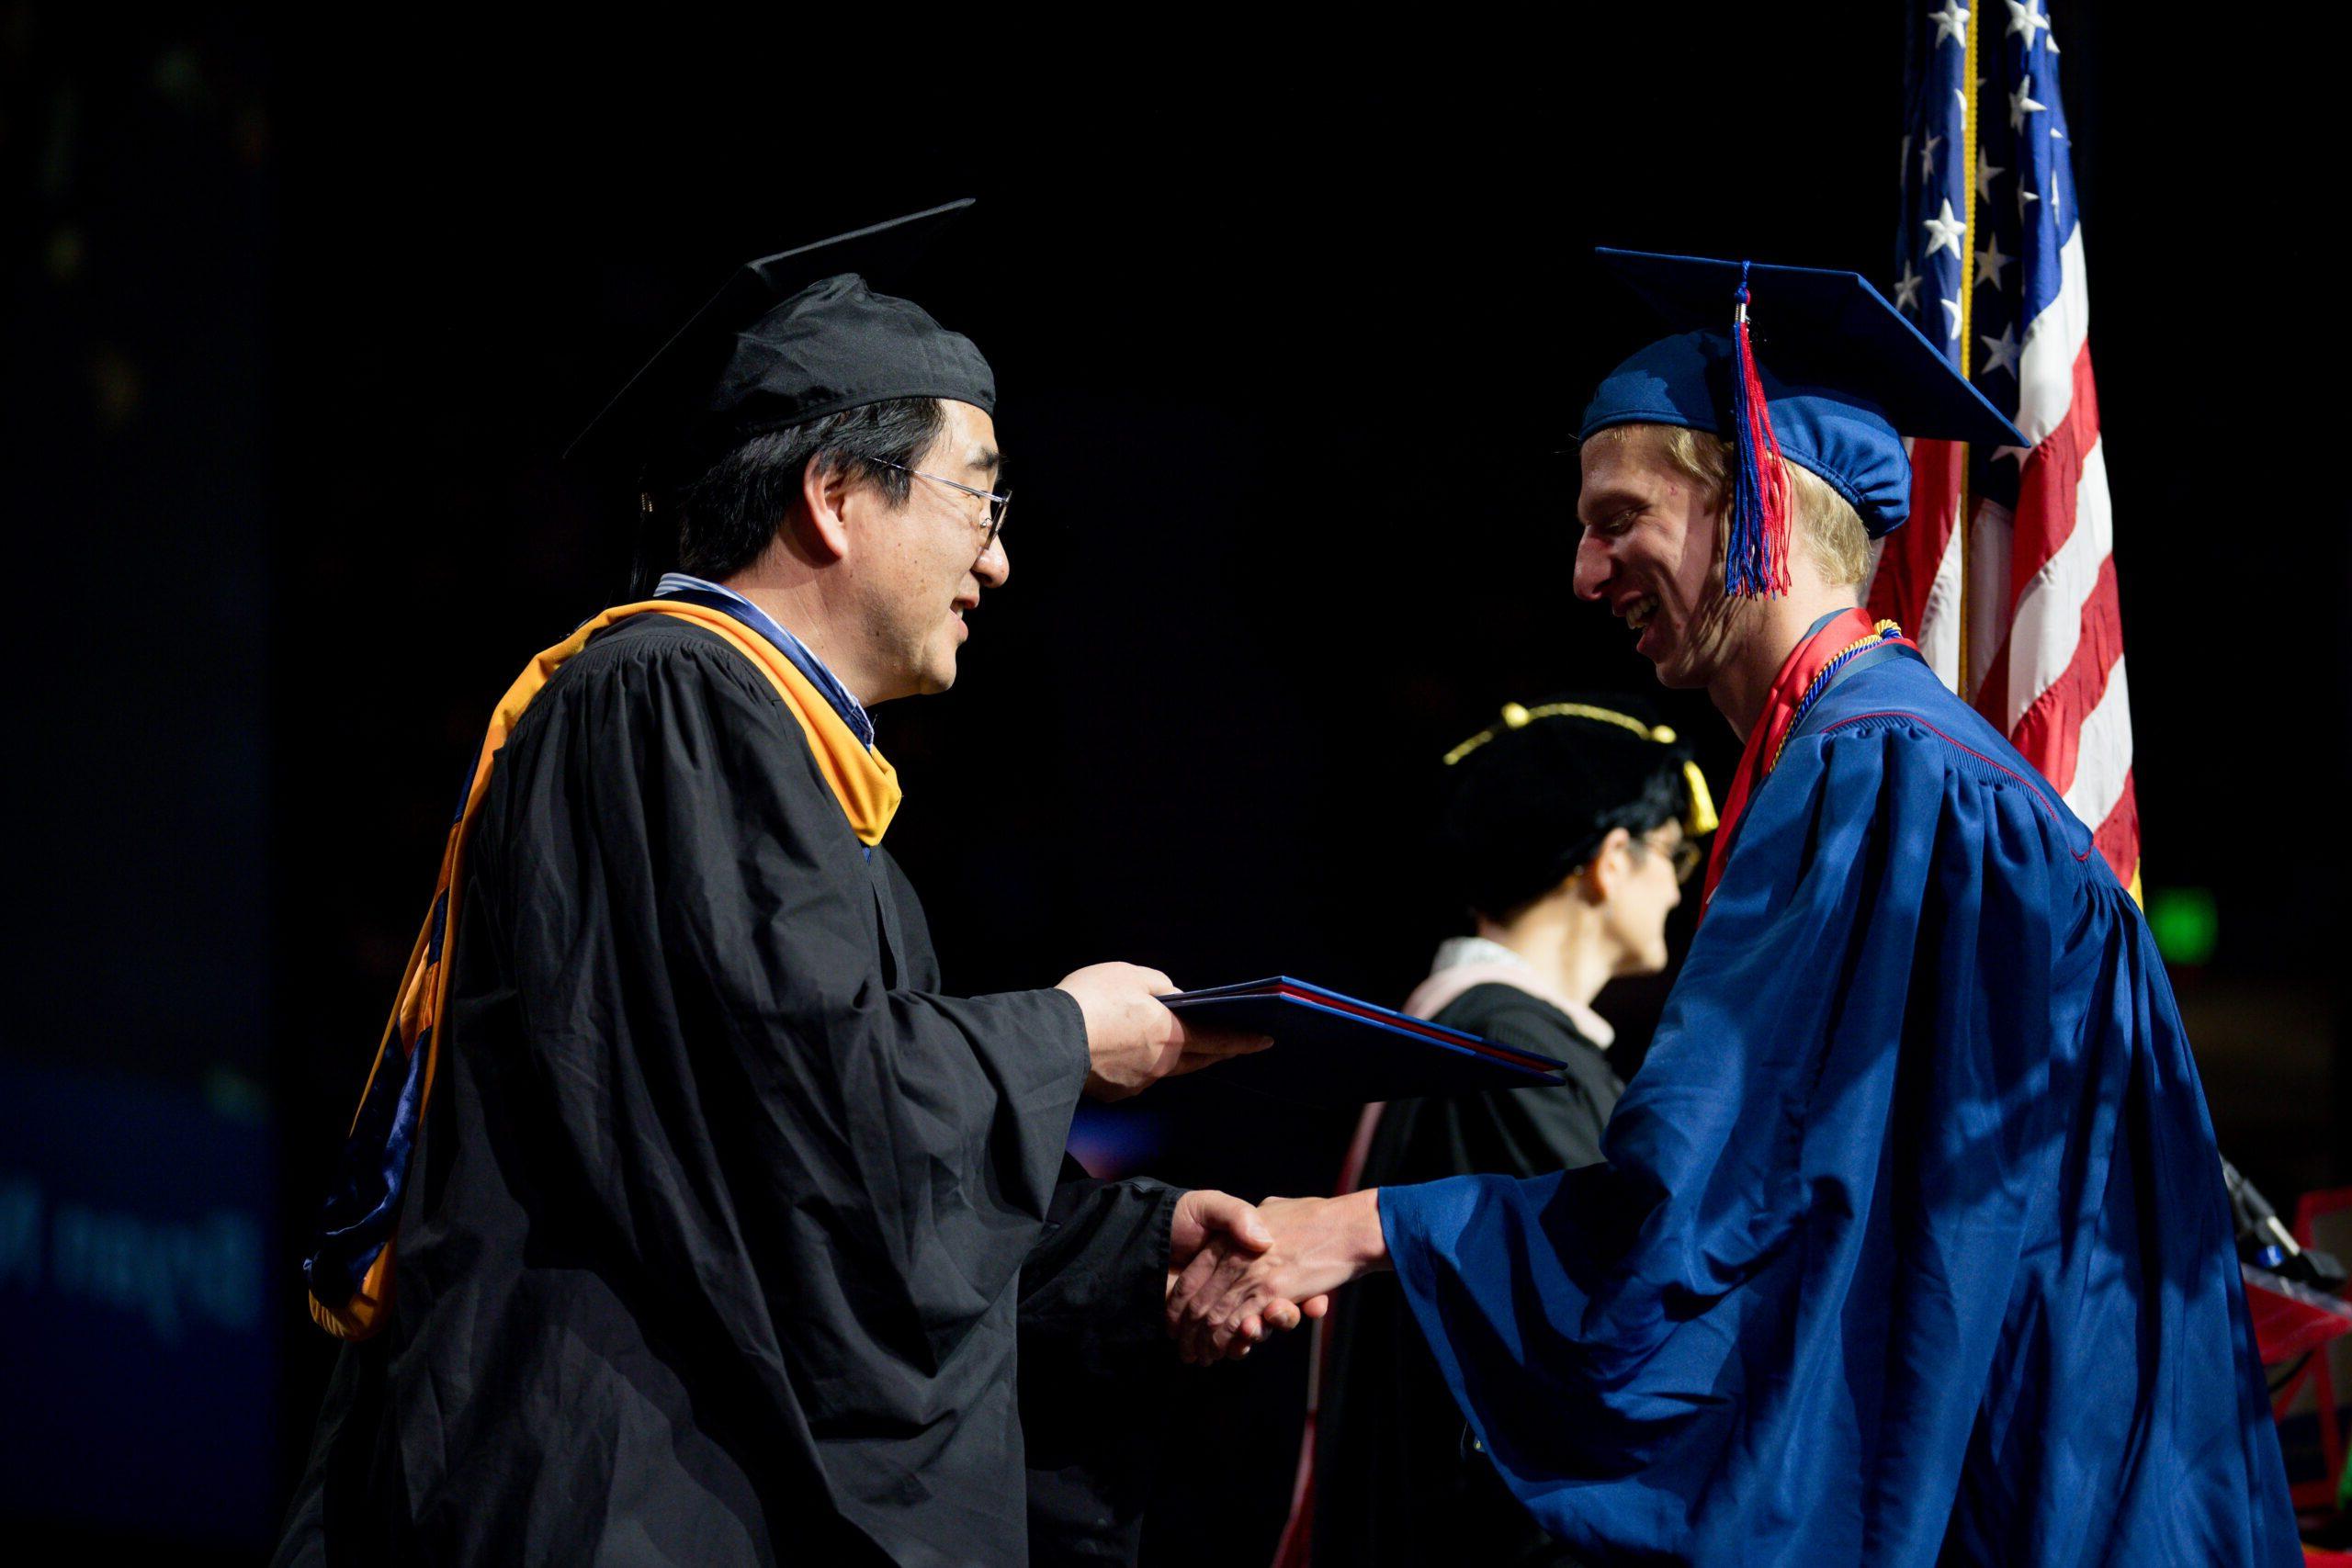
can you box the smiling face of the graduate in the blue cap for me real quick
[1576,425,1750,686]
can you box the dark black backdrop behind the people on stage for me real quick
[0,0,2352,1563]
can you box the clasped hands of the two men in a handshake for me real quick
[1167,1190,1387,1366]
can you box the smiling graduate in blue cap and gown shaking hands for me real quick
[1173,252,2301,1568]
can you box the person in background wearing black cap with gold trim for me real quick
[1294,696,1714,1568]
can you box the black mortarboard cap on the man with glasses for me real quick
[567,197,997,478]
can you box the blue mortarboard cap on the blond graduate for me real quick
[1578,249,2030,538]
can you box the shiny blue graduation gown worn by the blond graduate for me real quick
[1381,715,2293,1563]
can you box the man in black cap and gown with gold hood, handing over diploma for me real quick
[277,214,1298,1565]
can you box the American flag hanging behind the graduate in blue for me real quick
[1870,0,2141,894]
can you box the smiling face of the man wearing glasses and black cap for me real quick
[842,402,1012,703]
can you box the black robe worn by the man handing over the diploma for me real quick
[277,616,1179,1565]
